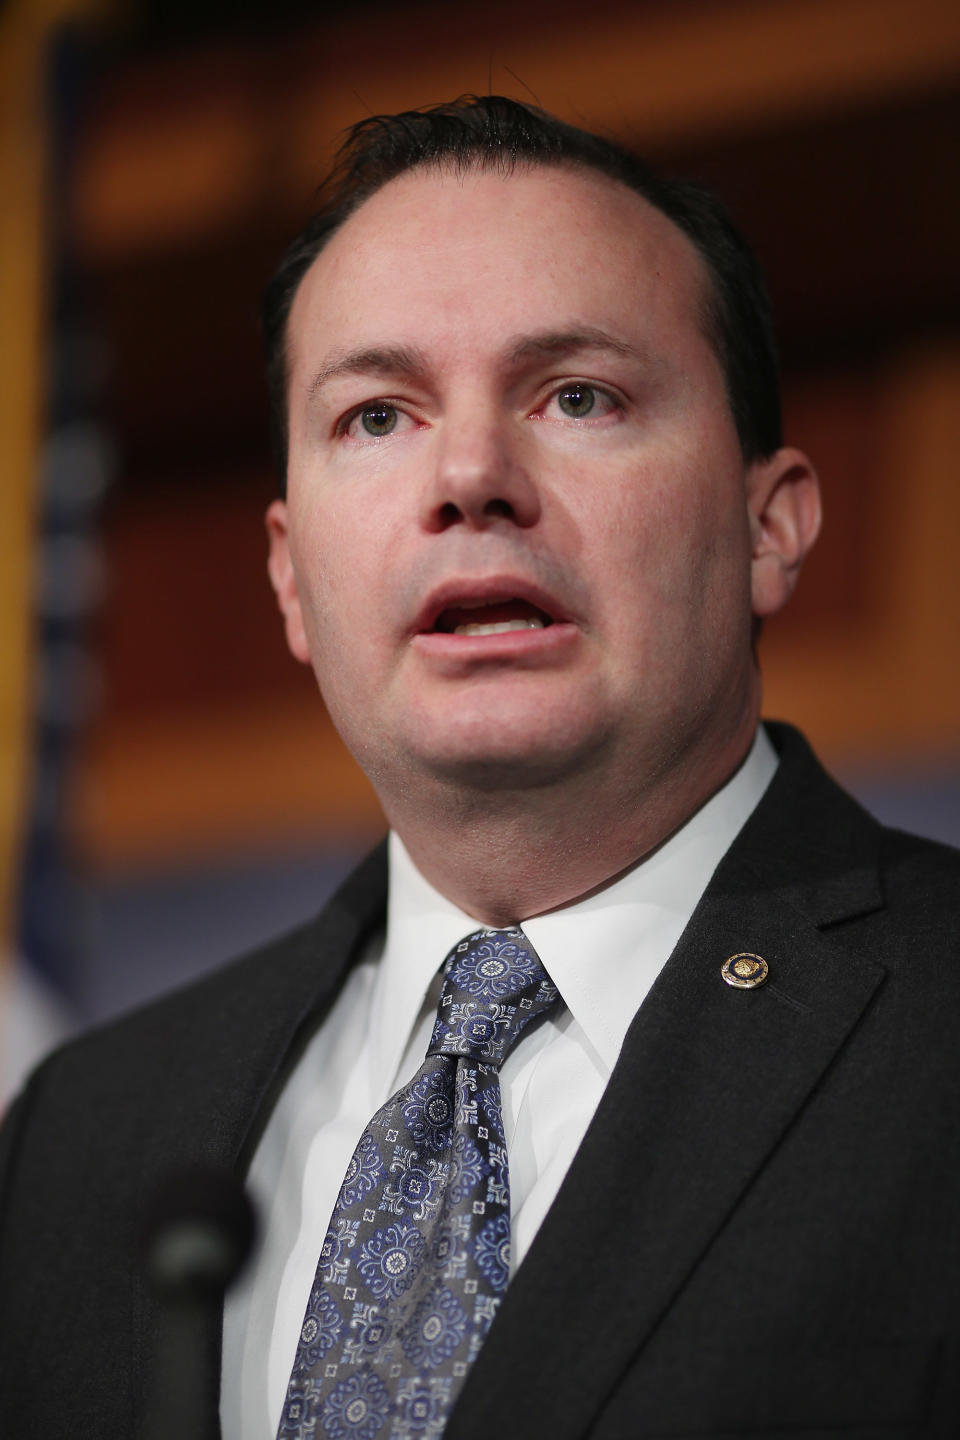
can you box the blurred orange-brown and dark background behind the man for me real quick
[0,0,960,1093]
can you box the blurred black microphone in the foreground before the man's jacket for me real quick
[140,1166,256,1440]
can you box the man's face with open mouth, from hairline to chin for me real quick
[271,168,782,796]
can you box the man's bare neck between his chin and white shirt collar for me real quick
[384,720,753,927]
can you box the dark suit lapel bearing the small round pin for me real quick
[449,736,884,1440]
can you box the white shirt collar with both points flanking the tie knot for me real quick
[370,726,777,1094]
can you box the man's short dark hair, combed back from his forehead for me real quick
[263,95,782,474]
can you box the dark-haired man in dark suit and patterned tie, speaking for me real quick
[0,98,960,1440]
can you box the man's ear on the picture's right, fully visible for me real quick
[747,449,820,616]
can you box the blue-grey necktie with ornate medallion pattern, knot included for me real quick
[278,929,557,1440]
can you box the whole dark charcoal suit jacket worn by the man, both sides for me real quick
[0,729,960,1440]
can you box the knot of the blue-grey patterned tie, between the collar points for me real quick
[427,926,558,1067]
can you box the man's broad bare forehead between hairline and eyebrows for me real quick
[288,167,712,384]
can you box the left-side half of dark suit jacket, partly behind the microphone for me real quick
[0,847,386,1440]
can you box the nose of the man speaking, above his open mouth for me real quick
[423,415,540,531]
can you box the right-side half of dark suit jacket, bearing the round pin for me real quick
[448,727,960,1440]
